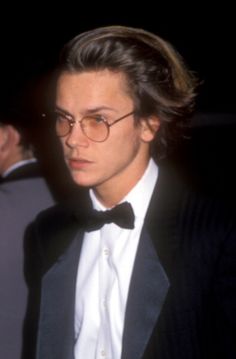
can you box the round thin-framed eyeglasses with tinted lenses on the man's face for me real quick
[42,110,134,142]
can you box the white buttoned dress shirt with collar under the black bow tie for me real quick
[74,159,158,359]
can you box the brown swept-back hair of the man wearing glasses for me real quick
[57,26,198,159]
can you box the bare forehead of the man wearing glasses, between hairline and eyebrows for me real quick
[56,70,132,107]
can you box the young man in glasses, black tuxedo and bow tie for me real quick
[25,26,236,359]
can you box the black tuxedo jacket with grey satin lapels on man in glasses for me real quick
[26,162,236,359]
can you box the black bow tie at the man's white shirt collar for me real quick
[77,202,134,232]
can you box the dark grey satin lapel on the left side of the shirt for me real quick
[39,233,83,359]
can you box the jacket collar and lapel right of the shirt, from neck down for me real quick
[122,162,182,359]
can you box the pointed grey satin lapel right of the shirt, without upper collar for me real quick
[122,230,169,359]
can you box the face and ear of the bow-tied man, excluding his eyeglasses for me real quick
[56,70,157,202]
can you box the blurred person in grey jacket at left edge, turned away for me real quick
[0,68,54,359]
